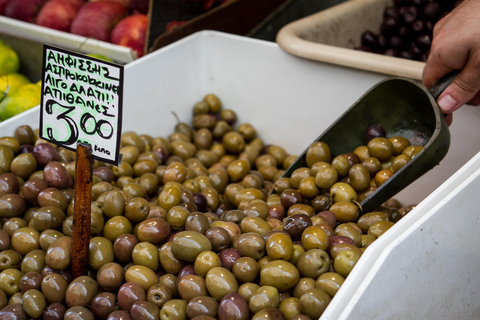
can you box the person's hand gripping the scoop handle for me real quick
[423,0,480,117]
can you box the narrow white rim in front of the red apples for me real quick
[0,16,137,64]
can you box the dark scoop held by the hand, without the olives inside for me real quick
[283,72,457,213]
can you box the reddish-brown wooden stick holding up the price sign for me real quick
[71,143,93,278]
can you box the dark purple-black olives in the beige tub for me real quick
[357,0,463,61]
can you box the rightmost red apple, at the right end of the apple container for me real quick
[111,14,148,58]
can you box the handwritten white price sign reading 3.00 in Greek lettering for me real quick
[39,45,123,165]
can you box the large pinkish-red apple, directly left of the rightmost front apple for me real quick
[70,0,128,42]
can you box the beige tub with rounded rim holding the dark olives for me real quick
[276,0,425,80]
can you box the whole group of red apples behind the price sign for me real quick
[0,0,150,57]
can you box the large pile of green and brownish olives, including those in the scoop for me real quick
[0,94,419,320]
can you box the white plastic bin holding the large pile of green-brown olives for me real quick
[0,31,480,320]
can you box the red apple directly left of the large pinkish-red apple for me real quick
[35,0,80,32]
